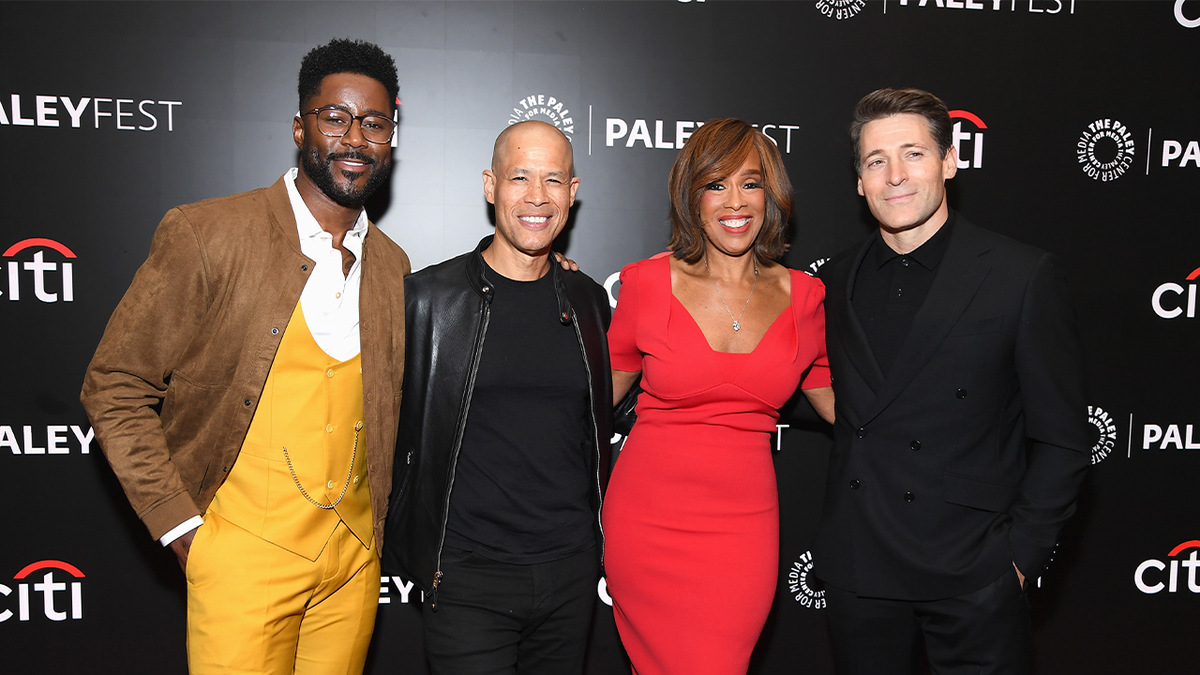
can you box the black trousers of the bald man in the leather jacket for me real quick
[422,548,600,675]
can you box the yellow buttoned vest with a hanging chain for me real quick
[210,303,374,560]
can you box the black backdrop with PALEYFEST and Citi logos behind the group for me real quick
[0,0,1200,675]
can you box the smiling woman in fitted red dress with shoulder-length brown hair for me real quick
[604,119,833,675]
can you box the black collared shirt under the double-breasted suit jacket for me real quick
[851,211,954,376]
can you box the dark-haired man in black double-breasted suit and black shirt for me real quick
[814,89,1091,675]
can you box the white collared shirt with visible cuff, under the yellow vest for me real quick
[158,168,367,546]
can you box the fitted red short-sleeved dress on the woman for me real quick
[604,253,829,675]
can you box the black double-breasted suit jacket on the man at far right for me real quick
[812,216,1092,601]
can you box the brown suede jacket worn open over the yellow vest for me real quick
[80,179,410,551]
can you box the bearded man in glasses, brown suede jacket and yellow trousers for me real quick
[82,40,410,674]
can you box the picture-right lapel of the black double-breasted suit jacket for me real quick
[862,216,991,424]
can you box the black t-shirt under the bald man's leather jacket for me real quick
[446,263,597,565]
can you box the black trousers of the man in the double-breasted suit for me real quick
[826,569,1030,675]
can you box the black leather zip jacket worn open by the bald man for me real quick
[383,237,612,610]
